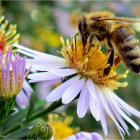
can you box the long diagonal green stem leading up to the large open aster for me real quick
[4,100,63,135]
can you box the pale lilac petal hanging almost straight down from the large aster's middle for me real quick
[77,84,89,118]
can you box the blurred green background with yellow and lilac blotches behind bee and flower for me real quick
[0,0,140,139]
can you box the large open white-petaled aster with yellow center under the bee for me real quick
[14,35,140,138]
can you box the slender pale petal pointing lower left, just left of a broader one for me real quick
[47,76,80,102]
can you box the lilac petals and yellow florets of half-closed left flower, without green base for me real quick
[0,50,27,98]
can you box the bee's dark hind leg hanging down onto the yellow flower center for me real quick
[104,38,114,75]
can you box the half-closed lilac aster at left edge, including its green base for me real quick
[0,50,28,124]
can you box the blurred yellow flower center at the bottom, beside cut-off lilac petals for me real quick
[48,114,79,140]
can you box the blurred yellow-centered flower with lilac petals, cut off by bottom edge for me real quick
[47,114,103,140]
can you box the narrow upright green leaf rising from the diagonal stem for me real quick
[26,93,37,120]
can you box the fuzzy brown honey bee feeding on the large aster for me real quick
[78,11,140,75]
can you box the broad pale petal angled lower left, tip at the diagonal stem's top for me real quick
[62,79,85,104]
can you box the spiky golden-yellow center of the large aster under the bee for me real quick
[61,37,128,90]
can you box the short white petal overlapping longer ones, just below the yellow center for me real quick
[87,80,97,101]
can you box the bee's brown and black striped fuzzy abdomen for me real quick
[111,26,140,73]
